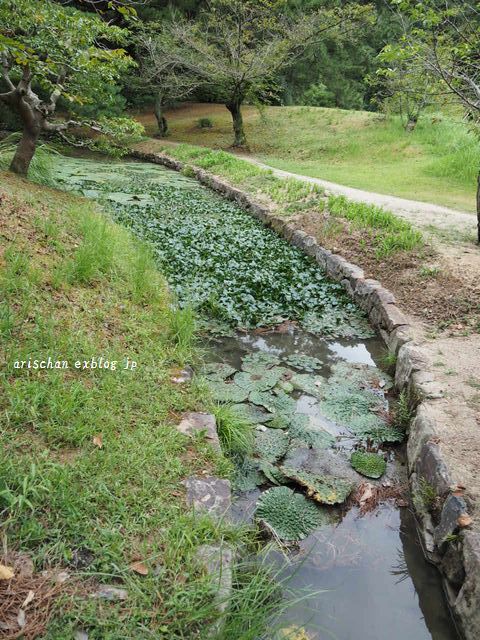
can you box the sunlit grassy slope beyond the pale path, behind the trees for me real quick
[133,104,480,211]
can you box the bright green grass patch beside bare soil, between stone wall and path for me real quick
[328,196,424,257]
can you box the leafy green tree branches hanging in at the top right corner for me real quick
[382,0,480,244]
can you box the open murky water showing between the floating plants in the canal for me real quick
[50,158,457,640]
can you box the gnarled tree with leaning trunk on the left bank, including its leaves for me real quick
[0,0,133,175]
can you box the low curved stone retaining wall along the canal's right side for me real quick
[132,151,480,640]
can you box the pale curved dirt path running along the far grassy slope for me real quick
[237,154,476,233]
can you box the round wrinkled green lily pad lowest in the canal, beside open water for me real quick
[255,487,320,541]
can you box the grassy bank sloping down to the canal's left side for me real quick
[0,173,262,640]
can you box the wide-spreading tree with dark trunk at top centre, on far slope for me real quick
[159,0,370,146]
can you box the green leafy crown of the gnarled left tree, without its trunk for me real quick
[0,0,132,105]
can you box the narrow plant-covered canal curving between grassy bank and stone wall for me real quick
[50,158,457,640]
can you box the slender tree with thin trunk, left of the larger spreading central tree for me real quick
[132,24,202,138]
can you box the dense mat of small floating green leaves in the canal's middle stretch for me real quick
[54,156,367,336]
